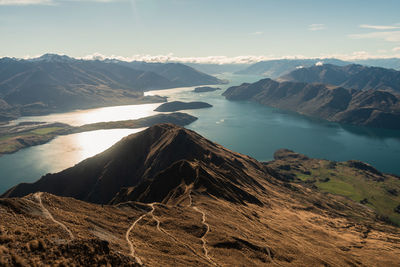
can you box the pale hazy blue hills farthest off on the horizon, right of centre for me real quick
[236,58,350,78]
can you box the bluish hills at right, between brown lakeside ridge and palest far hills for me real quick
[280,64,400,92]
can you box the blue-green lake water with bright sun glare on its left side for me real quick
[0,75,400,192]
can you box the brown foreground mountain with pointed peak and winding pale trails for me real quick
[0,124,400,266]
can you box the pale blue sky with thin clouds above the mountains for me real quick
[0,0,400,63]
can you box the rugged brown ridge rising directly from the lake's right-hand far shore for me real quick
[223,78,400,129]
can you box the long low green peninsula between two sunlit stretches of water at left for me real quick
[0,112,197,157]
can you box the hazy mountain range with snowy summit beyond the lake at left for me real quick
[0,54,222,120]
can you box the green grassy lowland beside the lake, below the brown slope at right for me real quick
[270,152,400,225]
